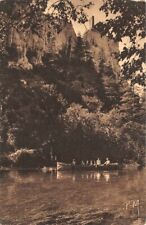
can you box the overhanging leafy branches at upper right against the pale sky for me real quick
[96,0,145,85]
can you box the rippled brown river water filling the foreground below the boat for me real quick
[0,170,146,225]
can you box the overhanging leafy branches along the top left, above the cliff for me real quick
[0,0,92,29]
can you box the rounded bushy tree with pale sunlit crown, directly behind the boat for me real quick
[60,103,110,161]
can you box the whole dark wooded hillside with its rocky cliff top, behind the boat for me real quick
[0,1,145,167]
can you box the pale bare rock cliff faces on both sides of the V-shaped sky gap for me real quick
[7,2,120,73]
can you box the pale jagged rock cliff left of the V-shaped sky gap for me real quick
[8,22,76,70]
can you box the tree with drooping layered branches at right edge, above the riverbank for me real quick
[110,79,146,163]
